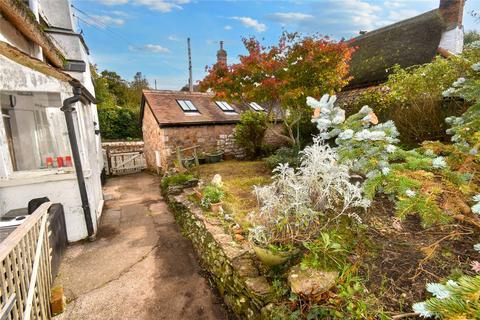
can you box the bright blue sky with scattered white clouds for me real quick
[71,0,480,90]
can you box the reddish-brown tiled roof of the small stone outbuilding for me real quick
[140,90,242,127]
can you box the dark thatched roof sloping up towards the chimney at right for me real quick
[346,9,446,90]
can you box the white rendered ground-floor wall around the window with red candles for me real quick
[0,55,103,241]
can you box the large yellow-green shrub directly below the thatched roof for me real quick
[346,48,480,147]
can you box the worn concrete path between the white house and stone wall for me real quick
[55,173,227,320]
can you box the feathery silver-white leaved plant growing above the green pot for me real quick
[250,137,370,246]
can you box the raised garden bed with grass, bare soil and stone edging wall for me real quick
[166,161,480,319]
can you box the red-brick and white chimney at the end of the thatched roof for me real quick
[438,0,465,56]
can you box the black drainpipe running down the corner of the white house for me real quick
[60,86,94,240]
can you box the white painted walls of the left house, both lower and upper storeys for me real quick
[0,0,103,242]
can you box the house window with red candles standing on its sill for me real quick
[0,92,71,171]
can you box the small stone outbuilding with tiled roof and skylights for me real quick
[140,90,282,170]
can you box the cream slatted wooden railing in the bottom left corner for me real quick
[0,202,52,320]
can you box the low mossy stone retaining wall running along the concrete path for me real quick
[165,189,273,319]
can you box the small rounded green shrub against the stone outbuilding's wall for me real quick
[235,110,268,158]
